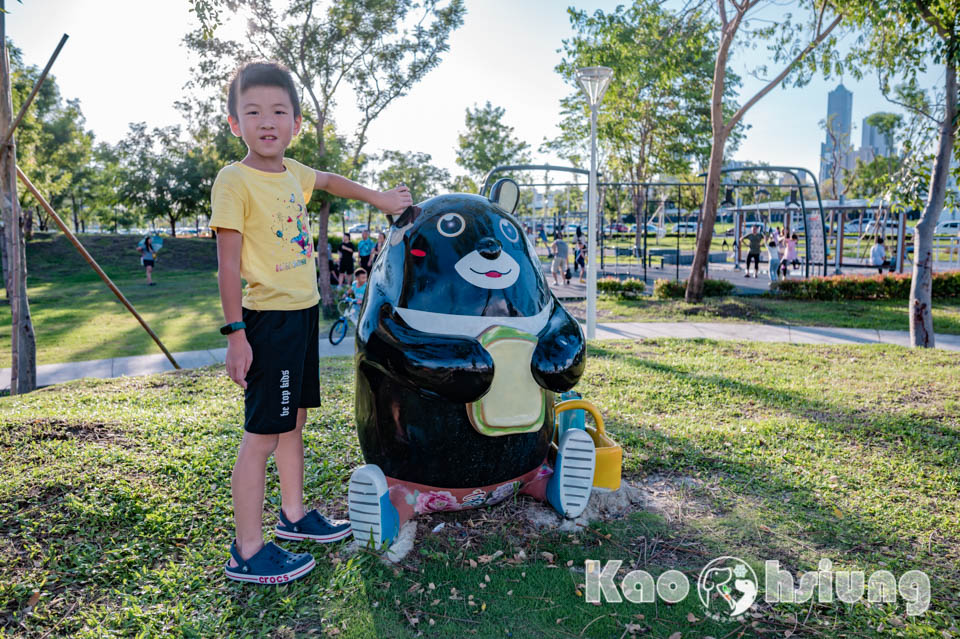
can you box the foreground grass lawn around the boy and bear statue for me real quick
[0,340,960,639]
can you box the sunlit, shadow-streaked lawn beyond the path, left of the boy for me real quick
[0,235,338,368]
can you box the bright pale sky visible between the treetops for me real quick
[6,0,936,185]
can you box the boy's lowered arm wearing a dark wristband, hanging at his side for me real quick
[217,228,253,388]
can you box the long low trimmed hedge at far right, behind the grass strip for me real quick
[770,271,960,301]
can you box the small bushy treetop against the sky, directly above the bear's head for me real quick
[456,101,530,184]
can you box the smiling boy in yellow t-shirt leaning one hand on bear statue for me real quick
[210,63,412,584]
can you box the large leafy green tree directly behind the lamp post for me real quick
[546,0,742,258]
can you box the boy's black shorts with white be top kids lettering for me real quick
[243,306,320,435]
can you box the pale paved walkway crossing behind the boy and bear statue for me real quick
[0,322,960,390]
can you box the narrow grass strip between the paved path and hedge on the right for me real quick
[564,296,960,335]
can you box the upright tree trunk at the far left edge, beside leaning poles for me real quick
[0,40,37,395]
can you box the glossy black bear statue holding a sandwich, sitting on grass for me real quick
[349,179,595,547]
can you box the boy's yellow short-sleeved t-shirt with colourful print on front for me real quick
[210,158,320,311]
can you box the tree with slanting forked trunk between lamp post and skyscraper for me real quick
[686,0,844,302]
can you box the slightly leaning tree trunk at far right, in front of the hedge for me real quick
[910,60,957,348]
